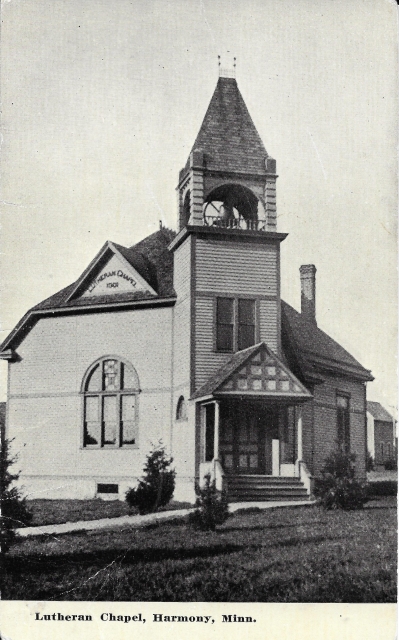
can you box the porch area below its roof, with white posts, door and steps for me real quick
[200,398,311,502]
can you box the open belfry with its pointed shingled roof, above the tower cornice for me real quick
[177,70,277,231]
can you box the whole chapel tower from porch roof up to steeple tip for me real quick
[169,70,286,397]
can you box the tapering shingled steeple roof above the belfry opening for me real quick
[186,77,268,174]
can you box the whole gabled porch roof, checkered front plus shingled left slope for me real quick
[191,342,313,404]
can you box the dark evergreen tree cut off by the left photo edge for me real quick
[0,439,32,553]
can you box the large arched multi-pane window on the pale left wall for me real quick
[82,356,140,448]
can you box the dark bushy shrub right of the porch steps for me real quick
[314,450,368,510]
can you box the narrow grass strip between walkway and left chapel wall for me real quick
[27,498,192,527]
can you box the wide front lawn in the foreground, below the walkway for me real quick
[2,497,396,602]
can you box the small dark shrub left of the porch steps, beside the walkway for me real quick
[189,473,229,531]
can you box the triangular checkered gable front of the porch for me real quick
[218,350,311,397]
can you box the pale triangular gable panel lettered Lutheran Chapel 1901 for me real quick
[81,255,152,298]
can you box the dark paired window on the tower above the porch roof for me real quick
[216,298,256,351]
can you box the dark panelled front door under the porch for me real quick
[219,402,275,474]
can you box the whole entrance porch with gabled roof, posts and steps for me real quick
[192,343,312,500]
